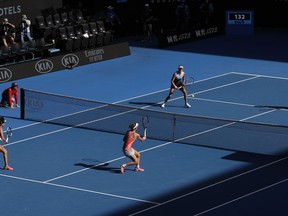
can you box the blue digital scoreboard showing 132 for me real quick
[226,10,254,34]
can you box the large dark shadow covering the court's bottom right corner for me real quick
[109,152,288,216]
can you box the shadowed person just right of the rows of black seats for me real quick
[105,6,121,34]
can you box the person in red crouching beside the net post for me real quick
[1,82,19,108]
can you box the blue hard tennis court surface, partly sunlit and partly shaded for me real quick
[0,32,288,216]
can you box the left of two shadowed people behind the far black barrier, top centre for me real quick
[175,0,190,31]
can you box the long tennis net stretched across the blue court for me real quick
[21,89,288,155]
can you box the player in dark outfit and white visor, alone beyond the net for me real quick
[161,65,191,108]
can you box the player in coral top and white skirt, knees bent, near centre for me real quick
[121,123,147,173]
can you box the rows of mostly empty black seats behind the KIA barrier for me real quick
[0,10,113,65]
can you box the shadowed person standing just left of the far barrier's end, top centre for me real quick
[141,4,154,42]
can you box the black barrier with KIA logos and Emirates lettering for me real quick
[0,42,131,83]
